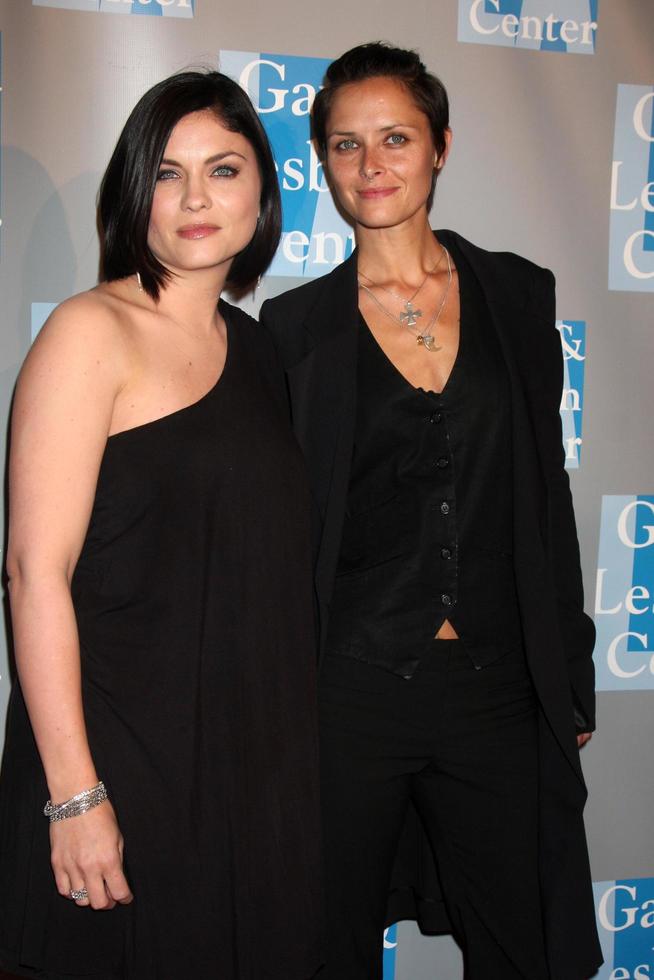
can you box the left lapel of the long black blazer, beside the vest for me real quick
[286,254,358,602]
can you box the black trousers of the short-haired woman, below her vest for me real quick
[320,640,549,980]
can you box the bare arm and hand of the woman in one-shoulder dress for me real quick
[7,296,131,908]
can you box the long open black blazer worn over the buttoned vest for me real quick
[261,231,601,980]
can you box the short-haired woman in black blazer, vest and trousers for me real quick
[262,44,601,980]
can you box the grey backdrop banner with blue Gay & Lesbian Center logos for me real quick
[0,0,654,980]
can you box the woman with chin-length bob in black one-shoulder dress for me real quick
[0,72,321,980]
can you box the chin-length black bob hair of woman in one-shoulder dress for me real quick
[98,71,281,300]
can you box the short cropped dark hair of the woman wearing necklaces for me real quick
[311,41,450,160]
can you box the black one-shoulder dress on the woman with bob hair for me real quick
[0,303,321,980]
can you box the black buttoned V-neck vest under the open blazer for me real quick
[327,241,522,678]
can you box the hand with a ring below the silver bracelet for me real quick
[50,800,134,909]
